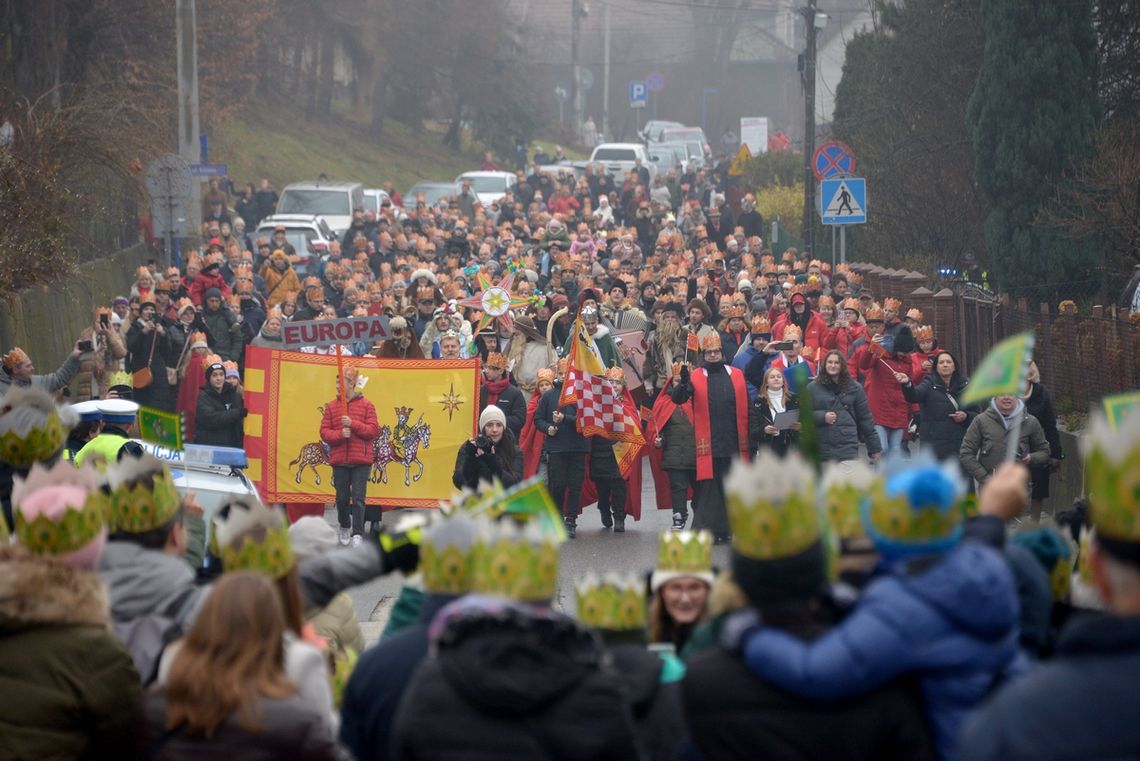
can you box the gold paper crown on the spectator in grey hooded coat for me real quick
[107,455,182,534]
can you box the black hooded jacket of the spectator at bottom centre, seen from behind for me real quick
[391,598,640,761]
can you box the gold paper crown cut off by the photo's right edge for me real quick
[1081,412,1140,542]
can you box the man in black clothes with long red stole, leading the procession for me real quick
[669,330,748,545]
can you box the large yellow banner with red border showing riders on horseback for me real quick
[245,347,479,507]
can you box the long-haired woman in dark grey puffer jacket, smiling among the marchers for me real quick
[807,350,882,461]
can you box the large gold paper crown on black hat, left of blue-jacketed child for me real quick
[725,449,822,560]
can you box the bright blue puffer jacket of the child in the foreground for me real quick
[743,541,1026,760]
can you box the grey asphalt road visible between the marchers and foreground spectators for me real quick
[344,464,728,644]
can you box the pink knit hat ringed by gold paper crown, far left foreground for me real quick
[11,463,109,568]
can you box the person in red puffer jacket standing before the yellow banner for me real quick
[320,367,380,545]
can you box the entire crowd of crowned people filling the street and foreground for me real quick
[0,150,1140,761]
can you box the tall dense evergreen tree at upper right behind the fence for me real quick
[967,0,1099,300]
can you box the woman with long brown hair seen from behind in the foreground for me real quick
[146,572,347,759]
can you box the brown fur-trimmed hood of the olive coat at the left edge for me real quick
[0,547,111,636]
